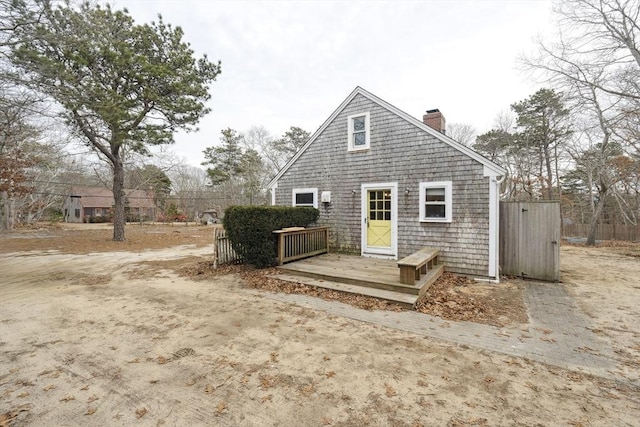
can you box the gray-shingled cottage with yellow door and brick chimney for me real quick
[268,87,506,278]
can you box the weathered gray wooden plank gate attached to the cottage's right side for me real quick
[500,201,560,282]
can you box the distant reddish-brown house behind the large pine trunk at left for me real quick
[63,186,156,222]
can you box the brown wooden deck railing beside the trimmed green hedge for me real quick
[273,227,329,265]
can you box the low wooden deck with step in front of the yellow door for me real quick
[278,254,444,306]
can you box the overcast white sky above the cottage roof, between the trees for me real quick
[110,0,551,165]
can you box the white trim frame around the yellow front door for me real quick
[360,182,398,259]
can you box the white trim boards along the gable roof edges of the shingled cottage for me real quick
[267,86,507,188]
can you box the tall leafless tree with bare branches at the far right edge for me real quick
[523,0,640,245]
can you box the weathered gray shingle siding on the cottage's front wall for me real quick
[275,94,489,276]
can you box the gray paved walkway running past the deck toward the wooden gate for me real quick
[268,282,626,381]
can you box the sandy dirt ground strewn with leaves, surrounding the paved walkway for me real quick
[0,226,640,426]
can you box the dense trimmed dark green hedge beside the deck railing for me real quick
[222,206,320,268]
